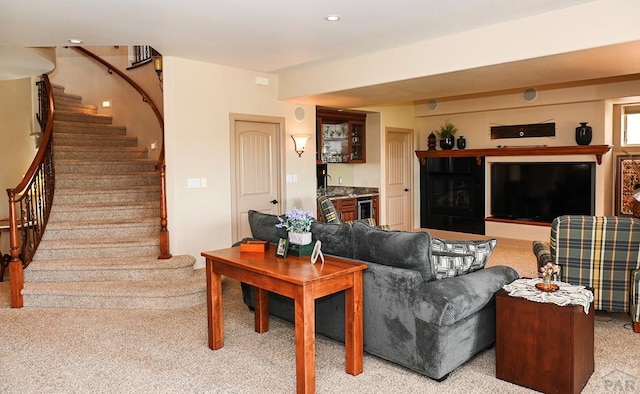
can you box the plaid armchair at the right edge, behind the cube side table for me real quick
[533,215,640,330]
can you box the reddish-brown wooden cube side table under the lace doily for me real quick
[496,290,594,394]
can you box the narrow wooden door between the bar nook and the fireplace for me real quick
[385,128,413,231]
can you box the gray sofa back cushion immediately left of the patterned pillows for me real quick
[353,222,434,281]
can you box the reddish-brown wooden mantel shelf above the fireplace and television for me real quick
[416,145,611,166]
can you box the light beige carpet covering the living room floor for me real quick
[0,242,640,394]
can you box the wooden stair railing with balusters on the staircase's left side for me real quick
[7,75,55,308]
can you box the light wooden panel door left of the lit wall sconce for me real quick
[231,116,284,242]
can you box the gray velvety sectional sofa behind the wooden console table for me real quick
[242,211,518,380]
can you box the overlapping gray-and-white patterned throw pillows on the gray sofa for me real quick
[431,238,498,279]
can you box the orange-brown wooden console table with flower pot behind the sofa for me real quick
[202,247,367,393]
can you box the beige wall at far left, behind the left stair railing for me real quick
[0,78,40,253]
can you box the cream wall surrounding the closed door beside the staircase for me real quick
[164,57,316,265]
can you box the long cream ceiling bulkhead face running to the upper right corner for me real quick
[280,0,640,98]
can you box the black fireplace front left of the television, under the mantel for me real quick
[420,157,485,234]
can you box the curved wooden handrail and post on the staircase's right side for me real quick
[71,46,171,259]
